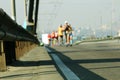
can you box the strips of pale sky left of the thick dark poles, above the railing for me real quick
[0,0,25,25]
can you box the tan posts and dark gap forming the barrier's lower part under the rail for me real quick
[0,41,37,71]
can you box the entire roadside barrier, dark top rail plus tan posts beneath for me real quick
[0,9,39,71]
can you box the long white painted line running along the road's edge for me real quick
[46,48,80,80]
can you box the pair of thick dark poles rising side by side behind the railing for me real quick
[27,0,39,35]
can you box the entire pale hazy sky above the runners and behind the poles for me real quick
[0,0,120,32]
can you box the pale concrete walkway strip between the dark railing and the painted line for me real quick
[0,47,64,80]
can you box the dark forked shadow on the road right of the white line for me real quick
[48,47,117,80]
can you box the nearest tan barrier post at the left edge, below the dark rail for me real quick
[0,41,7,71]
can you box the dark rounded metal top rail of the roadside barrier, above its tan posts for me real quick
[0,8,39,44]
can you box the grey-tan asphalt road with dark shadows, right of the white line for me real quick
[49,40,120,80]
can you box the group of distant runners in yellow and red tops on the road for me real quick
[48,21,73,46]
